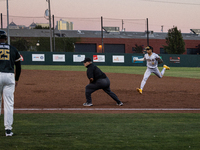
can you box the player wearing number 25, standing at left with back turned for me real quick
[0,30,21,136]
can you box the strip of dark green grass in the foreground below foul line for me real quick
[0,113,200,150]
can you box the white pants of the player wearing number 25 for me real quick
[3,74,15,130]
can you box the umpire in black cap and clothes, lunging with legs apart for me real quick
[82,58,123,106]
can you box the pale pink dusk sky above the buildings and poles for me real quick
[0,0,200,33]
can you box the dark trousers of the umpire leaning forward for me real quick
[85,77,121,104]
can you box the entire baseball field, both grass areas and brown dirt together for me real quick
[0,66,200,150]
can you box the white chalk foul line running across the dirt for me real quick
[14,108,200,111]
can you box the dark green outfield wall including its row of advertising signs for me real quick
[20,51,200,67]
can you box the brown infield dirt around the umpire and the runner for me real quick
[12,70,200,113]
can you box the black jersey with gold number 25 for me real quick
[0,43,21,73]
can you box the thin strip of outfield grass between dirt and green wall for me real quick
[22,65,200,79]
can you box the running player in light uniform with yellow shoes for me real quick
[134,46,170,94]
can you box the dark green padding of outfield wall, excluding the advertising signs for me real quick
[20,51,200,67]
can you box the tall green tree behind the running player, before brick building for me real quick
[163,27,185,54]
